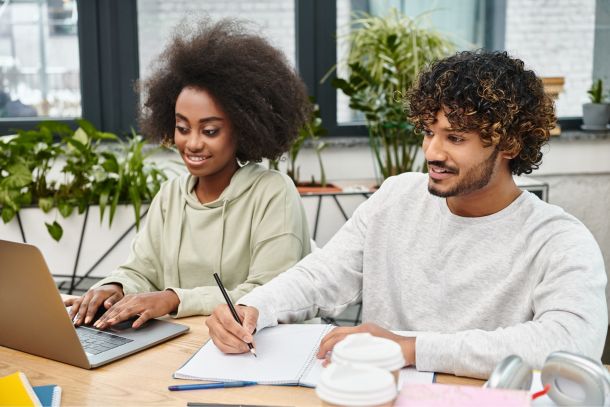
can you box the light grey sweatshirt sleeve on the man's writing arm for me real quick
[239,180,391,330]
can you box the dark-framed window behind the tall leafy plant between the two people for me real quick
[297,0,505,136]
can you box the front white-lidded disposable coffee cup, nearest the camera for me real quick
[316,364,397,407]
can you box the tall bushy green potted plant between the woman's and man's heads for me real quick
[332,9,454,182]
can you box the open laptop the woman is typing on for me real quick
[0,240,189,369]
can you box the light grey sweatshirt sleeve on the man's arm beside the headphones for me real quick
[416,234,608,378]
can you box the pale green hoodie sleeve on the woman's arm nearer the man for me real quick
[166,178,310,318]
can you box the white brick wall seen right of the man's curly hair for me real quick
[505,0,595,117]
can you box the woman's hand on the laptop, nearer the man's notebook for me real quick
[93,290,180,329]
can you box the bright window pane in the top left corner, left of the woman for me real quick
[0,0,81,121]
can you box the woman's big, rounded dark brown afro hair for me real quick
[137,19,311,161]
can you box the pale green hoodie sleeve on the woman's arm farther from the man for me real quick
[91,189,163,294]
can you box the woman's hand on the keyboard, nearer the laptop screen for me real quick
[64,284,123,326]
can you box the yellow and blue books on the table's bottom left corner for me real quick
[0,372,61,407]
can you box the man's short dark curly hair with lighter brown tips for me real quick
[407,50,556,175]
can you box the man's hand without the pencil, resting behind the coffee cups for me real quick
[317,323,415,366]
